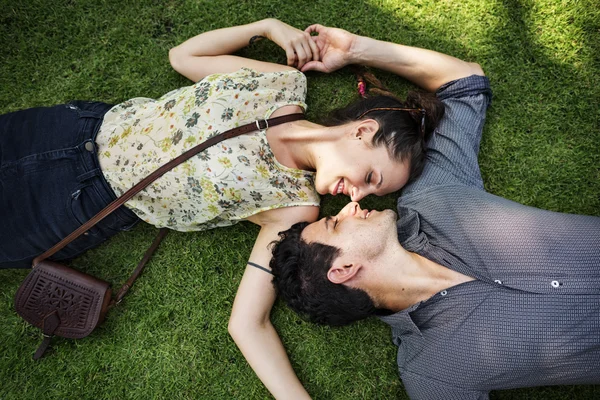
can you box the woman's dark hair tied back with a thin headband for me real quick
[323,69,444,182]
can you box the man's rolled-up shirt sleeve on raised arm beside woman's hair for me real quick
[403,75,492,194]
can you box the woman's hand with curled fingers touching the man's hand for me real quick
[264,18,319,69]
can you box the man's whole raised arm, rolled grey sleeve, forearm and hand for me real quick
[302,25,491,194]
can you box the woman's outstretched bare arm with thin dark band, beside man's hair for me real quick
[229,207,318,399]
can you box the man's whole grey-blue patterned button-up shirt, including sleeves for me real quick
[382,76,600,400]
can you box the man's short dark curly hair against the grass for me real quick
[270,222,376,326]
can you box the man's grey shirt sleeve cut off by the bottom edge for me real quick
[401,371,489,400]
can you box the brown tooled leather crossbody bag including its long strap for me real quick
[15,113,304,360]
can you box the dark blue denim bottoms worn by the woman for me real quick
[0,101,139,268]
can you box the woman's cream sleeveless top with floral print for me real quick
[96,68,319,231]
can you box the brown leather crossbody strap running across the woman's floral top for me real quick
[33,113,306,268]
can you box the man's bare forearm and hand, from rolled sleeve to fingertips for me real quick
[302,24,484,92]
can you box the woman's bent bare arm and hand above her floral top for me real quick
[169,18,319,82]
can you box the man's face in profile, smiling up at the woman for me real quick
[302,202,398,262]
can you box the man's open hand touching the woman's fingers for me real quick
[300,24,358,72]
